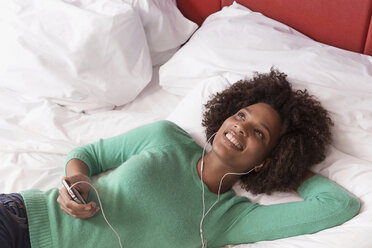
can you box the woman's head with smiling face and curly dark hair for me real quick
[203,69,333,193]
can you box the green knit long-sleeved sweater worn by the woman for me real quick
[21,121,359,248]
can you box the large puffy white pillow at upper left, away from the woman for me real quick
[0,0,152,111]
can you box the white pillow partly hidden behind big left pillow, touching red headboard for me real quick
[123,0,198,66]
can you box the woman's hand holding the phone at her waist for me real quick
[57,173,99,219]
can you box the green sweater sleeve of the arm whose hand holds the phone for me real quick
[65,121,190,176]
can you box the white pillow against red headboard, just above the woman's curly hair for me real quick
[159,2,372,95]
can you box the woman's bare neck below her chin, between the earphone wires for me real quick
[197,152,240,194]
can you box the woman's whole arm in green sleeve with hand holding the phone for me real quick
[57,121,191,218]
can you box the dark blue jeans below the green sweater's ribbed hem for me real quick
[0,194,31,248]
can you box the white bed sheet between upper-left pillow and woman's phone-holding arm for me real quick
[0,67,181,193]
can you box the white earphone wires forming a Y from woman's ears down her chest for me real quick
[199,133,264,248]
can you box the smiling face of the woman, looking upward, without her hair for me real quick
[212,103,281,172]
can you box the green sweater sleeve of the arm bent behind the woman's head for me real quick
[219,175,360,244]
